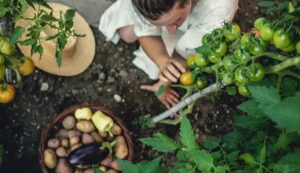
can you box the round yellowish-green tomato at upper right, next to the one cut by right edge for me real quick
[273,29,292,49]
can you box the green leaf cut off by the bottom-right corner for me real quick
[275,151,300,173]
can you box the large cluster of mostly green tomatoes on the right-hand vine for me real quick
[180,18,300,97]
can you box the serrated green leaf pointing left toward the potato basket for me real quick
[140,133,178,152]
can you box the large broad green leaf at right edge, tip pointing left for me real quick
[264,95,300,134]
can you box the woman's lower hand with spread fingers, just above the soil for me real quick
[141,80,179,109]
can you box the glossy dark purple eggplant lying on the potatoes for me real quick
[67,143,109,168]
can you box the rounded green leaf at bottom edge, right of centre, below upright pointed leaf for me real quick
[188,149,214,172]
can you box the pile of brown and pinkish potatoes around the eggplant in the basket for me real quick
[44,107,128,173]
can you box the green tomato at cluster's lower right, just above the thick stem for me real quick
[248,63,266,82]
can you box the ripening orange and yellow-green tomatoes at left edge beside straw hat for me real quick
[0,37,35,104]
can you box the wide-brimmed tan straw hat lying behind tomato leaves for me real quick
[16,3,95,76]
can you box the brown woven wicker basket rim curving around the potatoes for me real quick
[39,104,133,173]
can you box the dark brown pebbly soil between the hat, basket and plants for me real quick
[0,0,261,173]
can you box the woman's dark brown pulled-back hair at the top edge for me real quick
[132,0,195,20]
